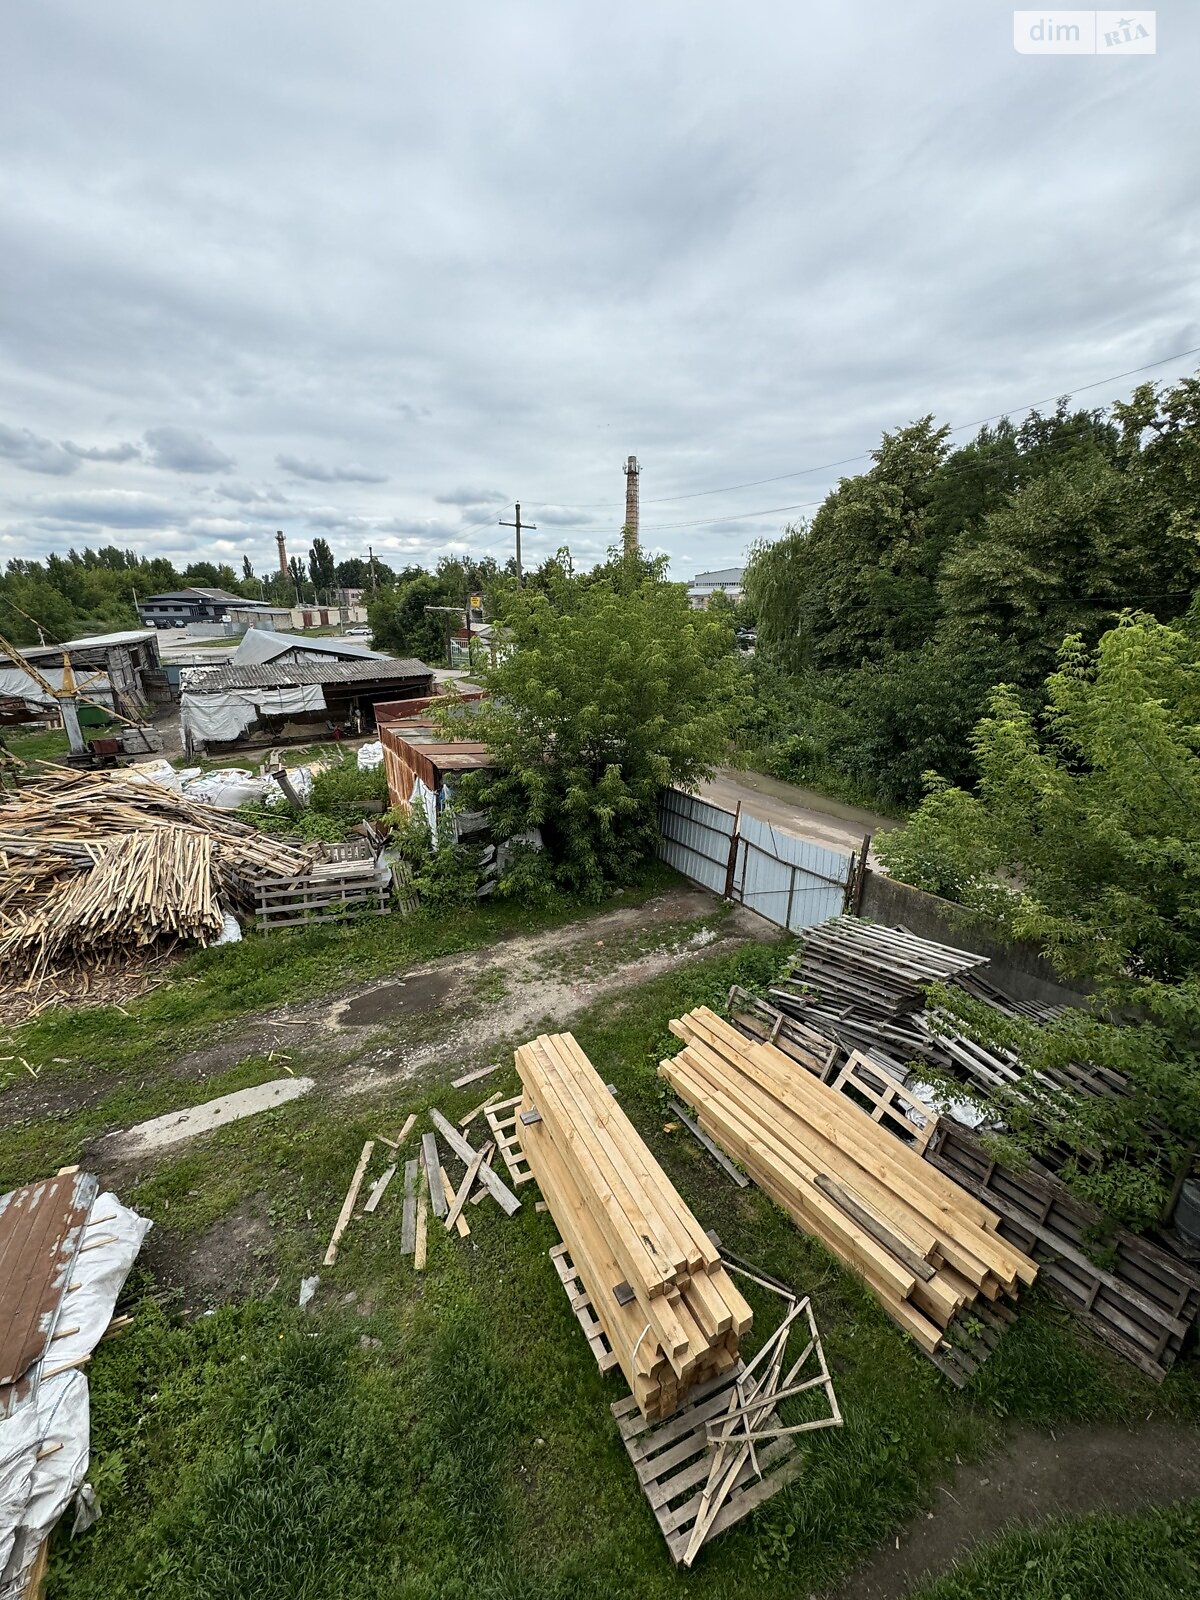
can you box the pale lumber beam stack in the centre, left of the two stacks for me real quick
[517,1034,750,1419]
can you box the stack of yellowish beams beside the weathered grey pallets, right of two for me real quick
[659,1006,1037,1355]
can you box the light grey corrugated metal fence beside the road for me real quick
[658,789,854,933]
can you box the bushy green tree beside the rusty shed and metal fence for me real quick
[451,578,742,896]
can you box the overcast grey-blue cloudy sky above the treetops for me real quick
[0,0,1200,576]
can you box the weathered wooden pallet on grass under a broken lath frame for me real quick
[610,1362,805,1566]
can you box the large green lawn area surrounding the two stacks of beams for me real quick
[37,944,1200,1600]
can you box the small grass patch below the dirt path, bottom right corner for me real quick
[914,1501,1200,1600]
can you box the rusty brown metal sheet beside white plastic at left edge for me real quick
[0,1173,99,1416]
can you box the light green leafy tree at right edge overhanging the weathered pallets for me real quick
[877,614,1200,1227]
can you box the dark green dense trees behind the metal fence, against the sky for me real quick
[744,378,1200,806]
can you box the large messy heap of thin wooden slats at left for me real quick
[0,768,312,1011]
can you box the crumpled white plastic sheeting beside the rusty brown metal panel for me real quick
[0,1194,150,1600]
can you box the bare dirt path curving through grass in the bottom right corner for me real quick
[827,1422,1200,1600]
